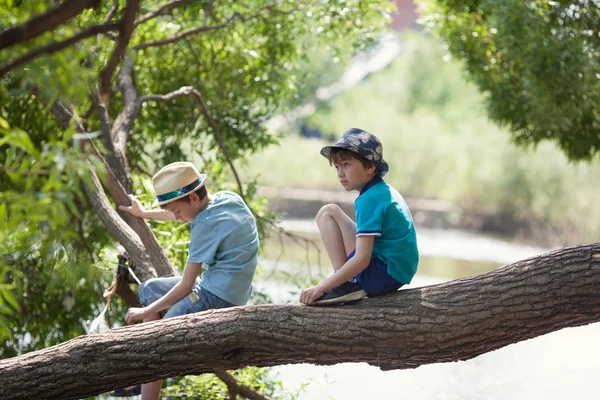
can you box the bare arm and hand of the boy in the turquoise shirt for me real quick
[300,236,375,304]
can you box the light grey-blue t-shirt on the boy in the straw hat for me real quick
[187,191,258,305]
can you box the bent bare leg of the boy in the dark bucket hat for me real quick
[316,204,356,271]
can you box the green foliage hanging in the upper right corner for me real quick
[423,0,600,160]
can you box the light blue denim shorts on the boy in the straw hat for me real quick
[138,276,235,318]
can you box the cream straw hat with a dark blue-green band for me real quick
[152,161,206,207]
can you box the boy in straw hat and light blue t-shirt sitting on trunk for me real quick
[119,162,259,399]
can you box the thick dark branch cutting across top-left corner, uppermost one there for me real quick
[0,0,100,50]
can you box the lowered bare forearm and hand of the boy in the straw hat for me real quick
[125,262,202,325]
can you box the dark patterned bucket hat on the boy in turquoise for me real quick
[321,128,390,176]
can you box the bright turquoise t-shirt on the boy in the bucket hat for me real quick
[354,177,419,284]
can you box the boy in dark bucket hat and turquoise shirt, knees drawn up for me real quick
[300,128,419,305]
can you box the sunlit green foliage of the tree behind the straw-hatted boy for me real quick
[0,0,390,398]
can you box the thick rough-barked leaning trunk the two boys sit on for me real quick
[0,243,600,399]
